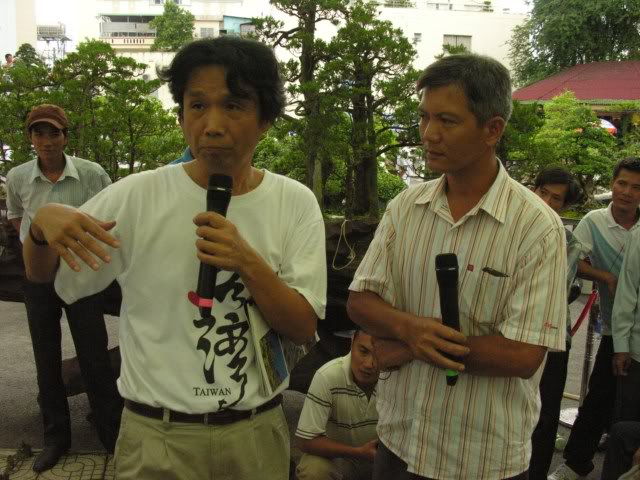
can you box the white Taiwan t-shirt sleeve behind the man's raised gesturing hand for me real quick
[55,181,132,304]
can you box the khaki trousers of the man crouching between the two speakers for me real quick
[296,453,373,480]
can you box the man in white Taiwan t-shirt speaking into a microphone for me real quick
[25,36,326,480]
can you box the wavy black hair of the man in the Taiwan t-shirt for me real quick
[158,35,285,123]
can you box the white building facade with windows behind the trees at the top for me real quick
[65,0,526,108]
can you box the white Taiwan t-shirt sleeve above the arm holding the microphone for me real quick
[278,189,327,318]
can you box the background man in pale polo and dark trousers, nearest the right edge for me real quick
[549,157,640,480]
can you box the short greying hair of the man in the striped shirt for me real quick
[417,53,513,125]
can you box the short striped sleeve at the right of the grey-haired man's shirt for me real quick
[500,225,567,351]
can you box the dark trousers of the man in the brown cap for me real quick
[24,281,123,452]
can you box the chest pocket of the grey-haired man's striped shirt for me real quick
[459,266,512,335]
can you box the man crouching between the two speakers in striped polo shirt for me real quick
[296,330,379,480]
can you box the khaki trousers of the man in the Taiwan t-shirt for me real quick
[114,406,289,480]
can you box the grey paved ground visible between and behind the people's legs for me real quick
[0,296,603,480]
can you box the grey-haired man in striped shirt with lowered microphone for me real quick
[348,55,567,480]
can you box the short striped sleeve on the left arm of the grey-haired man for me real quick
[349,204,396,305]
